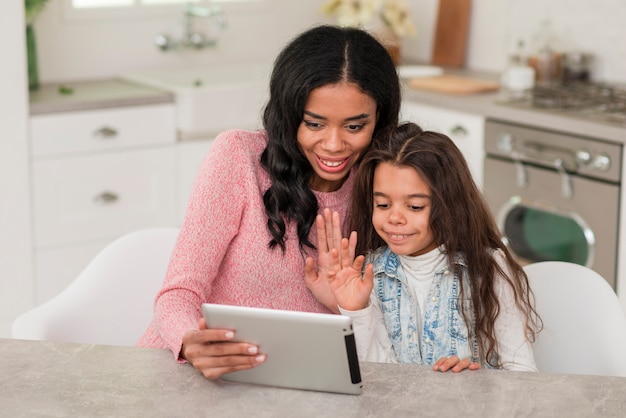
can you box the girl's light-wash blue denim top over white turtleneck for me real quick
[367,247,488,367]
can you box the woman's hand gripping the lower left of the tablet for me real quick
[180,318,266,380]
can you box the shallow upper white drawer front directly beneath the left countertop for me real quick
[30,103,176,158]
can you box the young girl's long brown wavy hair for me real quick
[349,123,542,367]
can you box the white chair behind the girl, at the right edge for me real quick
[524,261,626,376]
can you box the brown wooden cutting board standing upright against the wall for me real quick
[432,0,471,67]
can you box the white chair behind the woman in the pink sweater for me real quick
[12,228,179,346]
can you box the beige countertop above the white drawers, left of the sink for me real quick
[30,79,174,115]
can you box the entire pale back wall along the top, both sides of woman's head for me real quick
[36,0,626,82]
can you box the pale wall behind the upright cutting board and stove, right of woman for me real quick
[405,0,626,83]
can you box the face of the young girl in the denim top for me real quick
[372,163,437,256]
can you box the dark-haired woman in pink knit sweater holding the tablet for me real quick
[138,26,400,379]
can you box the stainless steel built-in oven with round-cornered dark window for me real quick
[484,120,622,288]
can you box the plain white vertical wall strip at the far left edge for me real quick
[0,1,33,337]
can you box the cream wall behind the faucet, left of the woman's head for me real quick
[36,0,330,82]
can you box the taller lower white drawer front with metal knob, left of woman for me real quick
[33,146,179,248]
